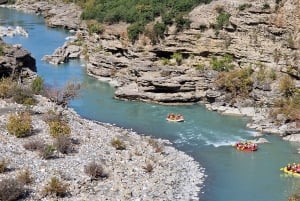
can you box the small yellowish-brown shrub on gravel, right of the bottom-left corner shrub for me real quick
[44,177,68,197]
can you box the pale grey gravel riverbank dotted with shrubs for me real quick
[0,96,205,201]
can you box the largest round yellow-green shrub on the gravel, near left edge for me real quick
[6,112,32,138]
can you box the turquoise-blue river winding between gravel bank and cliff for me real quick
[0,8,300,201]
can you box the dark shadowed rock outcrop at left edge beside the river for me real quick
[0,40,36,79]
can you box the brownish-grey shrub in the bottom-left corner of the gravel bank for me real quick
[0,178,26,201]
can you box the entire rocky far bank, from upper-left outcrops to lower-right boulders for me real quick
[6,0,300,140]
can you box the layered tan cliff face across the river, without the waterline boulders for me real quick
[78,0,300,106]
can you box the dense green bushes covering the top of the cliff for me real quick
[78,0,211,42]
